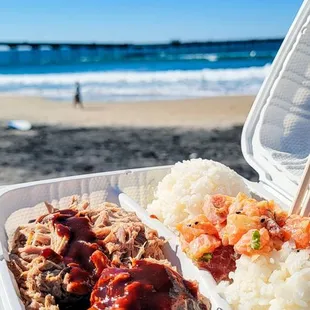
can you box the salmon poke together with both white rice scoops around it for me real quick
[147,159,310,310]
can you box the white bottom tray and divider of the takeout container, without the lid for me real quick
[0,166,286,310]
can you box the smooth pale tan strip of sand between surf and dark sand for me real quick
[0,96,254,129]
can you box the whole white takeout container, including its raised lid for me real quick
[0,1,310,310]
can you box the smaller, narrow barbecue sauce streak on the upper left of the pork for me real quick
[41,209,110,295]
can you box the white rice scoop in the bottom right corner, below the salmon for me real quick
[218,243,310,310]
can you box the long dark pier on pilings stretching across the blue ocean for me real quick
[0,38,283,65]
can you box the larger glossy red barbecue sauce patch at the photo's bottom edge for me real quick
[89,260,207,310]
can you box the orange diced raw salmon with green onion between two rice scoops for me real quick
[177,193,302,263]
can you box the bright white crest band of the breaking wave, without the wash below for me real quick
[0,65,270,85]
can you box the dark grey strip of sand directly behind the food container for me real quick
[0,126,257,185]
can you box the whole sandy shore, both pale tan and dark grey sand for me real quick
[0,96,257,185]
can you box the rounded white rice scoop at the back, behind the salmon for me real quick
[147,158,249,229]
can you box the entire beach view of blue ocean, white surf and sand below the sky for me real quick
[0,36,272,184]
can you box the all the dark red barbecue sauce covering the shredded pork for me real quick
[41,209,208,310]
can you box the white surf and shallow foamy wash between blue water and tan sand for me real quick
[0,65,270,100]
